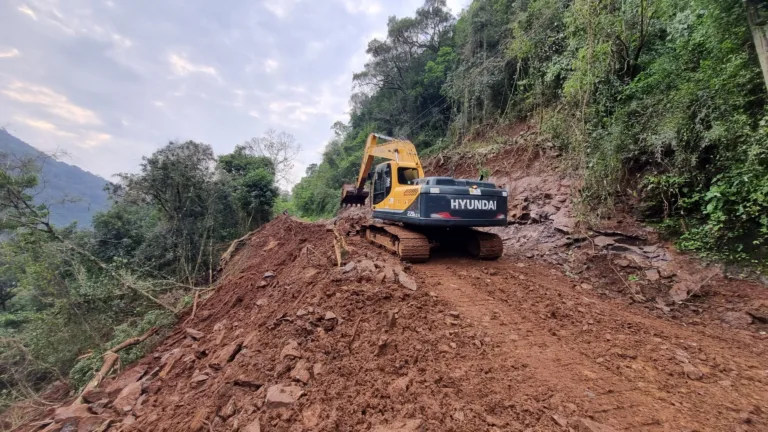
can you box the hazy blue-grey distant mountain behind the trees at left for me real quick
[0,129,109,227]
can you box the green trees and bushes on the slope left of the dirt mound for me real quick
[0,137,284,409]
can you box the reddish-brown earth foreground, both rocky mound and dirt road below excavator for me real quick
[20,213,768,432]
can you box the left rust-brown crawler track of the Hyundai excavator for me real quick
[363,224,429,263]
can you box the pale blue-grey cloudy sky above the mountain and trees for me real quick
[0,0,469,187]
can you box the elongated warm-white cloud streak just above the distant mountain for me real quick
[0,81,101,125]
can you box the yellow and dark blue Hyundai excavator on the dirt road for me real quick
[341,134,508,263]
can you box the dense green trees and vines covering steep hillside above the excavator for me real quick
[293,0,768,262]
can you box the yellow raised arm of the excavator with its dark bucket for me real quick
[341,134,424,205]
